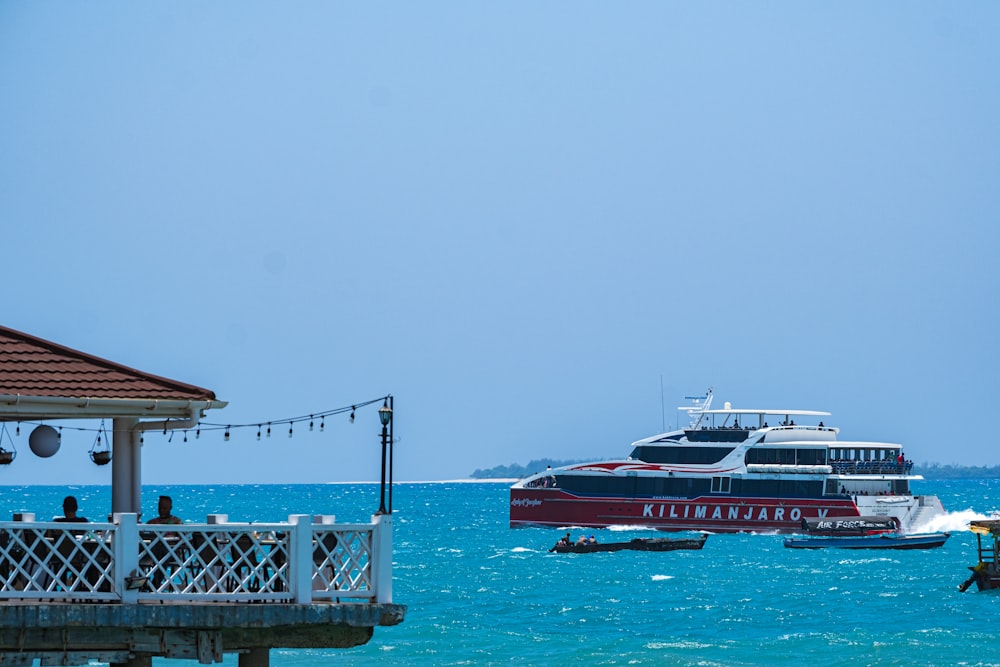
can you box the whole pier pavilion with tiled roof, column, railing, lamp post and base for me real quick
[0,327,406,667]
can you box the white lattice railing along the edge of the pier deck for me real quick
[0,514,392,604]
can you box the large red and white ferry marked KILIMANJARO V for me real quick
[510,390,944,534]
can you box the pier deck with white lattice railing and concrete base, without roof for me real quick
[0,514,405,667]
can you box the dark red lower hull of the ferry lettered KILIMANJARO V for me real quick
[510,489,860,533]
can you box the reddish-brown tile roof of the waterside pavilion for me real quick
[0,326,215,401]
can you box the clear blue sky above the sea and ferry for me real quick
[0,0,1000,484]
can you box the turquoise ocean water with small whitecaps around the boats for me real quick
[0,480,1000,667]
